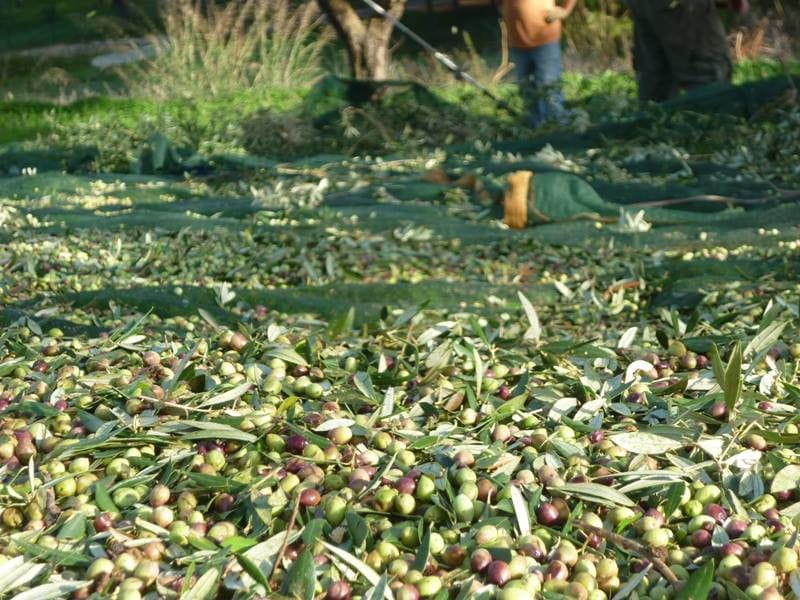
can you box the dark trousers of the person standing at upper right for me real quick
[627,0,732,102]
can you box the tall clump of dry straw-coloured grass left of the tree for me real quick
[125,0,330,99]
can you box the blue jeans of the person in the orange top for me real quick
[511,42,567,127]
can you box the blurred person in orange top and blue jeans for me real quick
[500,0,577,127]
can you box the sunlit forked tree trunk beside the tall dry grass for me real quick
[317,0,406,81]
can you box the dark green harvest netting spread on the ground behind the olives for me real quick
[0,79,800,329]
